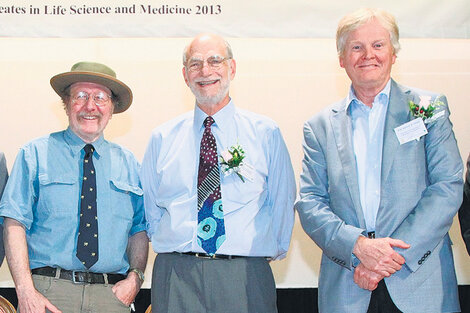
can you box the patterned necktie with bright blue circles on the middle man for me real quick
[197,116,225,255]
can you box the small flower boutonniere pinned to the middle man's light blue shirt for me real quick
[220,144,253,182]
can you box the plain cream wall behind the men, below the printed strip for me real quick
[0,38,470,287]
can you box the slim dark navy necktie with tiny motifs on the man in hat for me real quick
[77,144,98,268]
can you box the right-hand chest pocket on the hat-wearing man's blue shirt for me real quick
[110,179,143,222]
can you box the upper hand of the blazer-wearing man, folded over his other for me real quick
[353,236,410,277]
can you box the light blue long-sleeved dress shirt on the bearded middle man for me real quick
[141,101,296,259]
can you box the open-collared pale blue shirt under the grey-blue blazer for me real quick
[347,80,390,232]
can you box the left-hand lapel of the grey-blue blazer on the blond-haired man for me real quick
[330,99,365,228]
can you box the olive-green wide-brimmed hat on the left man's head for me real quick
[51,62,132,113]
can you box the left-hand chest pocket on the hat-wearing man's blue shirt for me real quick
[38,173,79,213]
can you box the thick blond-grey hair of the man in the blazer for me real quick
[336,8,400,56]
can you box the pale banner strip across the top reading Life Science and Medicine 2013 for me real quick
[0,0,470,38]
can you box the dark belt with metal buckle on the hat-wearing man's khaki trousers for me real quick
[31,266,126,285]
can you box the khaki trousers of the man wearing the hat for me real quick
[22,275,130,313]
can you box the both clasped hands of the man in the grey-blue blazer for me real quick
[353,236,410,291]
